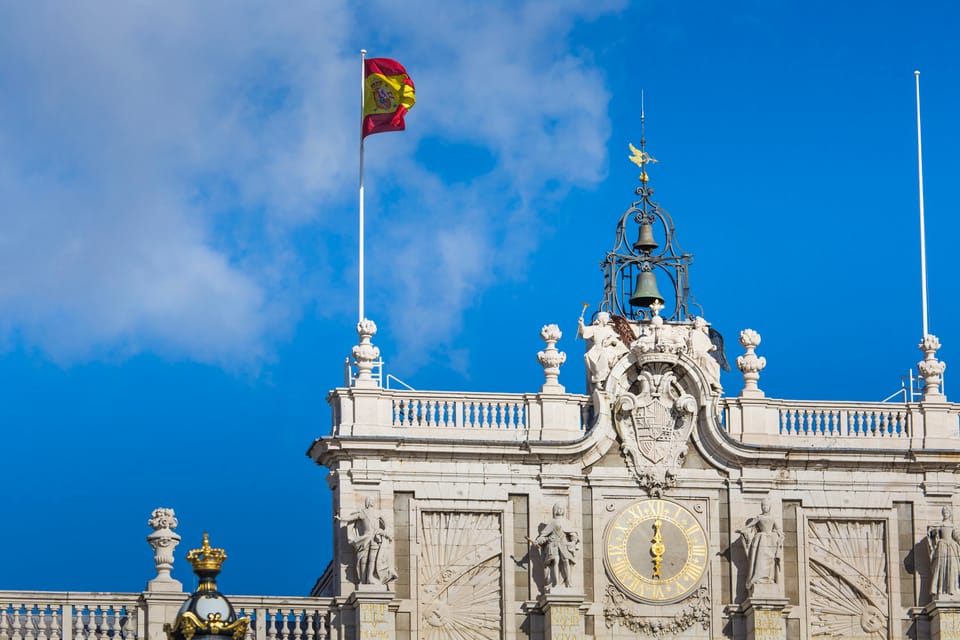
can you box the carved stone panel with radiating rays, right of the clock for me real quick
[807,520,889,640]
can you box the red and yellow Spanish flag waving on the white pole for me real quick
[362,58,417,138]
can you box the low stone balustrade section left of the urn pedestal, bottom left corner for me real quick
[0,591,142,640]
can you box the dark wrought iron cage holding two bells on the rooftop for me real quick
[600,180,703,322]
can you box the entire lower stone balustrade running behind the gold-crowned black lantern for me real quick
[0,591,330,640]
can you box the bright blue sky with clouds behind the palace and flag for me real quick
[0,0,960,595]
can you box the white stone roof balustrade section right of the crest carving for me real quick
[722,397,960,449]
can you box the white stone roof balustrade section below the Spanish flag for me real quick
[328,388,590,441]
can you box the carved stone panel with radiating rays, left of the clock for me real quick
[419,512,503,640]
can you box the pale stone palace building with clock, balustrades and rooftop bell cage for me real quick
[0,142,960,640]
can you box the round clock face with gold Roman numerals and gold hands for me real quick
[604,500,707,604]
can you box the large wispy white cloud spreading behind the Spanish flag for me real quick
[0,2,609,365]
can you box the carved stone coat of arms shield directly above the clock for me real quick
[613,369,697,497]
